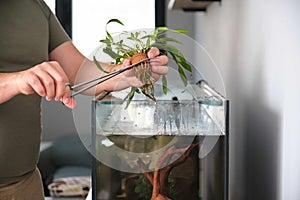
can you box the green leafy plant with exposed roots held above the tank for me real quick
[93,19,192,107]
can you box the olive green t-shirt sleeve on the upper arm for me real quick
[38,0,71,53]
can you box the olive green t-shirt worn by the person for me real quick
[0,0,70,184]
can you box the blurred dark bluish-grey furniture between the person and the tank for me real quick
[38,134,92,196]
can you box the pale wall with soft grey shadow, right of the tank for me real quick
[168,0,300,200]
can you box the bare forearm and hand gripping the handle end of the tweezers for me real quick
[0,61,69,103]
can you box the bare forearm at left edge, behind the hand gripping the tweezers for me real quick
[0,72,20,104]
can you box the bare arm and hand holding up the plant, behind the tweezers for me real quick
[50,41,168,95]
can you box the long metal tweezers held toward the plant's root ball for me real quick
[66,58,150,97]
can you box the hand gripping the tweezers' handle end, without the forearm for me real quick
[15,61,76,108]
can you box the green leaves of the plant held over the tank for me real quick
[98,19,192,108]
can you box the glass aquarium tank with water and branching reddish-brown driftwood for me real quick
[92,81,229,200]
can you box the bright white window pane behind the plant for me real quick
[72,0,155,56]
